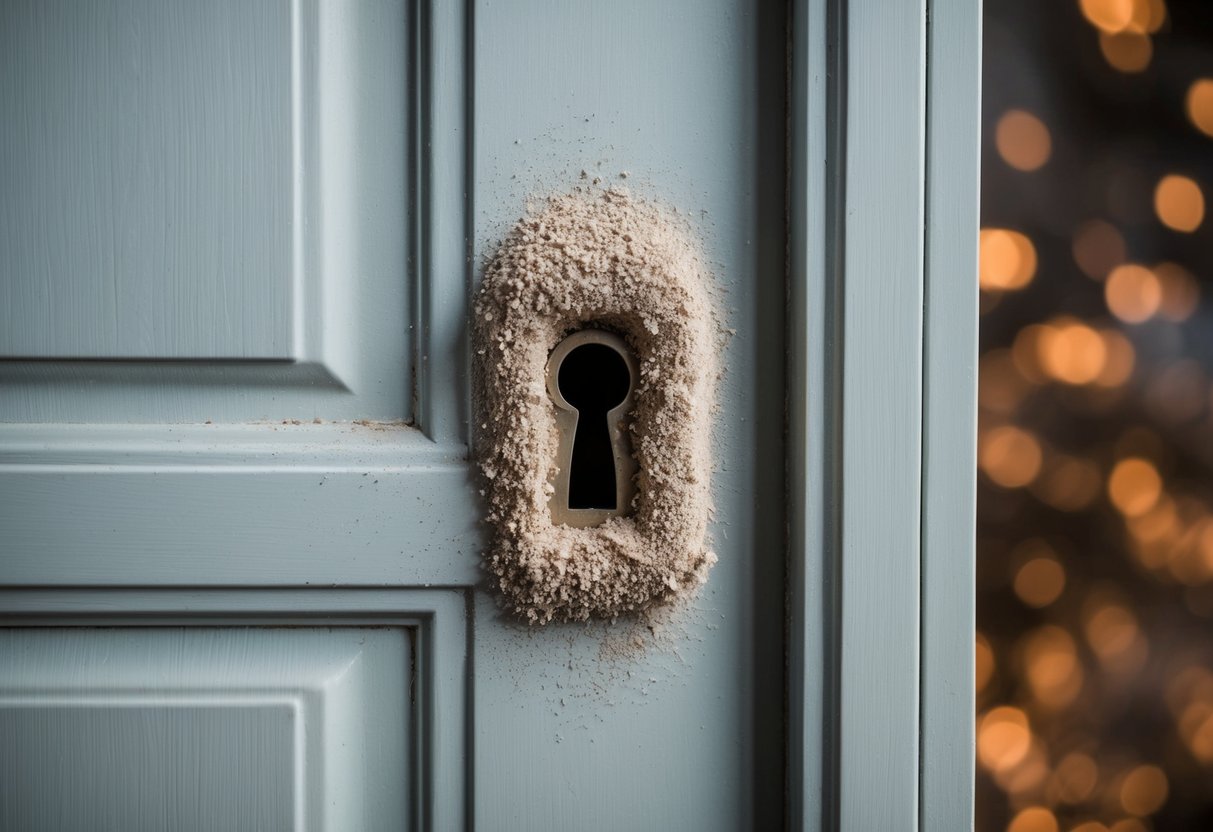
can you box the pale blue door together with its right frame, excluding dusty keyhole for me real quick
[0,0,978,832]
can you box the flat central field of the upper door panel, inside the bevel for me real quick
[0,0,292,358]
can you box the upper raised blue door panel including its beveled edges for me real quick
[0,0,412,423]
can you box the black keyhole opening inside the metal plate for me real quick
[557,343,632,511]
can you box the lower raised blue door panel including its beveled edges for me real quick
[0,627,415,832]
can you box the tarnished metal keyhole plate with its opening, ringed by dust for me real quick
[547,329,637,528]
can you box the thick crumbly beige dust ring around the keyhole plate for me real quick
[474,189,716,623]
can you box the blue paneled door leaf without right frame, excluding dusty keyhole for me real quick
[0,0,787,832]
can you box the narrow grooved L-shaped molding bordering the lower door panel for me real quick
[0,587,472,830]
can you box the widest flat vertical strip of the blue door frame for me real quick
[838,0,926,832]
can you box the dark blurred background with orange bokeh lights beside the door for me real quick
[976,0,1213,832]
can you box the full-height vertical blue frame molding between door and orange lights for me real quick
[788,0,981,831]
